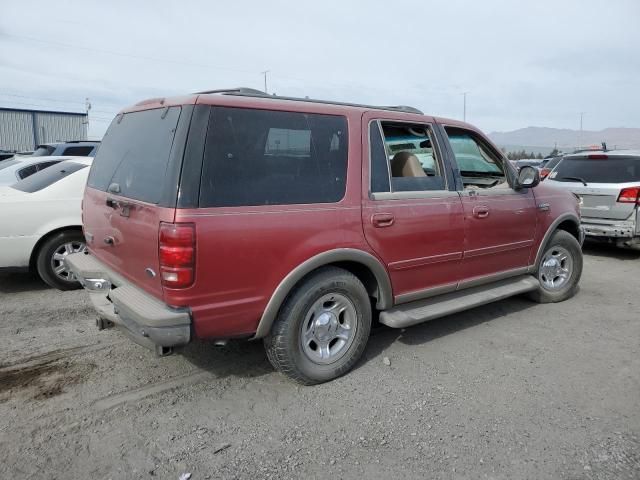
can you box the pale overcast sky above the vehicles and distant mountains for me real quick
[0,0,640,137]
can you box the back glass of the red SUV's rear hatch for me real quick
[87,107,181,203]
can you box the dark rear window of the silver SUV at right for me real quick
[549,157,640,183]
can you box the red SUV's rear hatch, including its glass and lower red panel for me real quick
[83,101,193,299]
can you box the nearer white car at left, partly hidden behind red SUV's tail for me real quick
[0,157,92,290]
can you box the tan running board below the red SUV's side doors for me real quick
[380,275,540,328]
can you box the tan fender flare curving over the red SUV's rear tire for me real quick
[253,248,393,339]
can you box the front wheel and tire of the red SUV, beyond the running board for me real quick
[529,230,583,303]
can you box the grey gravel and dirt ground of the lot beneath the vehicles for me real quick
[0,247,640,480]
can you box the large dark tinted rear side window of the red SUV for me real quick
[201,108,347,207]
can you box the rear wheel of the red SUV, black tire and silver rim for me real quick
[264,267,371,385]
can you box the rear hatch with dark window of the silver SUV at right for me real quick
[549,154,640,220]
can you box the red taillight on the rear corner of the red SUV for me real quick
[158,222,196,288]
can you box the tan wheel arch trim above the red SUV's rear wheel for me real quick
[253,248,393,339]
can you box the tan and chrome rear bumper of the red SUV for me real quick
[65,253,191,349]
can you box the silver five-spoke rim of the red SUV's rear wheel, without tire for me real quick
[300,293,358,364]
